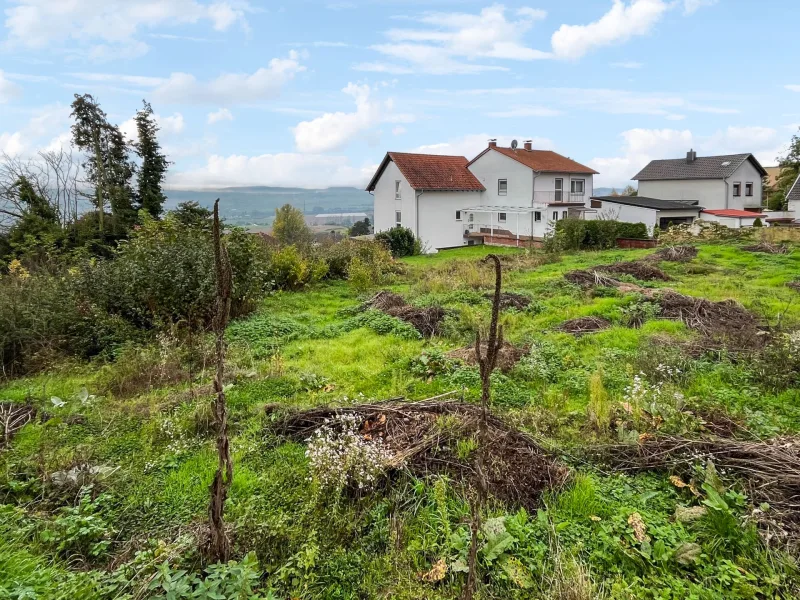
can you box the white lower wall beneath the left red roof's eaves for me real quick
[418,192,482,251]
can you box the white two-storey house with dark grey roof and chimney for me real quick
[633,150,767,212]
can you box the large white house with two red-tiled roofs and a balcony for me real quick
[367,140,597,250]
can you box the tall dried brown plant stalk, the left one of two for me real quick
[208,198,233,562]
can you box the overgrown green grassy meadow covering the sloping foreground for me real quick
[0,242,800,600]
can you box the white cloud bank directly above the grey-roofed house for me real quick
[589,127,782,187]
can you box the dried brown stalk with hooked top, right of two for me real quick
[463,254,503,600]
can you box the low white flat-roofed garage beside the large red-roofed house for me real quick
[590,196,703,235]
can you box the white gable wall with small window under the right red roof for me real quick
[469,150,533,206]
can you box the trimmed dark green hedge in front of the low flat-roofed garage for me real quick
[545,219,649,252]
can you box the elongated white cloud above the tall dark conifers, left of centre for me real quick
[153,51,305,105]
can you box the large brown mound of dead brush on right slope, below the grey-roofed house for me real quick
[654,291,765,349]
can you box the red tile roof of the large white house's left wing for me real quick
[367,152,486,192]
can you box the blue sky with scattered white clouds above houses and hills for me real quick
[0,0,800,189]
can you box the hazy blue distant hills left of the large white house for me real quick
[165,186,372,225]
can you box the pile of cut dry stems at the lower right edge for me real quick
[589,436,800,535]
